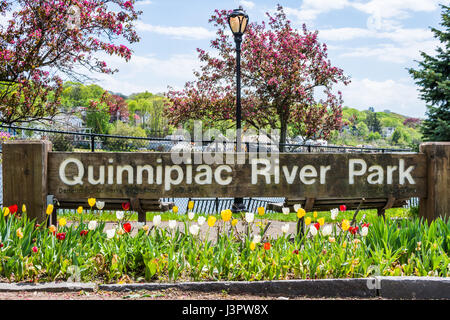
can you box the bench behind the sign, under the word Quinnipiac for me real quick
[47,196,175,224]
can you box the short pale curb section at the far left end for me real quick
[0,282,96,292]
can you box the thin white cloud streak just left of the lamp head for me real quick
[136,21,215,40]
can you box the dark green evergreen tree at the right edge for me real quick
[408,5,450,141]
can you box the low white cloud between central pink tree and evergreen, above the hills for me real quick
[340,78,426,117]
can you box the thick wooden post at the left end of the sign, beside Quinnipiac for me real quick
[2,141,52,223]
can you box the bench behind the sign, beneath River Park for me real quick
[267,197,408,217]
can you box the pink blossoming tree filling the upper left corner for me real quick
[0,0,141,124]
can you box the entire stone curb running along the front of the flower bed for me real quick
[0,277,450,299]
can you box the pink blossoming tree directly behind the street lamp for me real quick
[167,6,349,147]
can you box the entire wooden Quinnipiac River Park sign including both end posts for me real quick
[3,141,450,220]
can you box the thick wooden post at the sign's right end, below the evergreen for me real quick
[419,142,450,222]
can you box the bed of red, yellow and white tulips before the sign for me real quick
[0,199,450,283]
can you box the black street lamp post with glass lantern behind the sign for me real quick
[228,7,248,212]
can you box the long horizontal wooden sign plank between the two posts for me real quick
[48,152,427,200]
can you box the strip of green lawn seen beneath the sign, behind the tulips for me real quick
[58,208,414,222]
